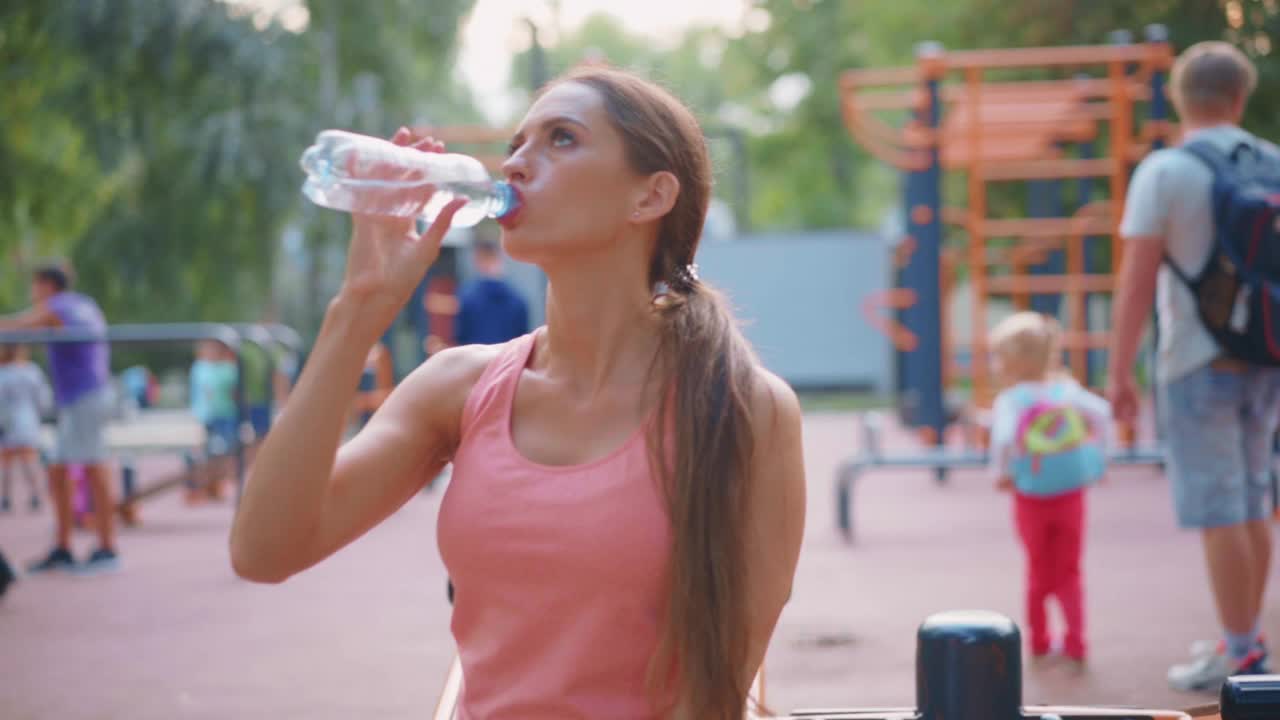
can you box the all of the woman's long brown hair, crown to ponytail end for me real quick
[561,68,755,720]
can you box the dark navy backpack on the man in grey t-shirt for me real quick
[1165,140,1280,366]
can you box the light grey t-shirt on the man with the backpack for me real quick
[1120,126,1280,383]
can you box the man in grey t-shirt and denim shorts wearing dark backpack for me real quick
[1108,42,1280,692]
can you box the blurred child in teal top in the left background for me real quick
[187,340,239,502]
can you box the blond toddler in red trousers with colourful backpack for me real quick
[989,313,1111,670]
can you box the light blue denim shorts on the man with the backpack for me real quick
[1158,365,1280,528]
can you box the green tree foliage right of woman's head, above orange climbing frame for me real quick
[513,0,1280,228]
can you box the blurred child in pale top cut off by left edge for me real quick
[0,343,54,511]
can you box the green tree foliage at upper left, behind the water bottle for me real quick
[0,0,472,330]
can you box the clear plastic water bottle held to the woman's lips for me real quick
[301,129,520,228]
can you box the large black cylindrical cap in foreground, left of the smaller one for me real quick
[915,611,1023,720]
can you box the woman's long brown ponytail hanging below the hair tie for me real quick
[650,275,755,720]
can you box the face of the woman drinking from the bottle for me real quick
[502,82,644,263]
